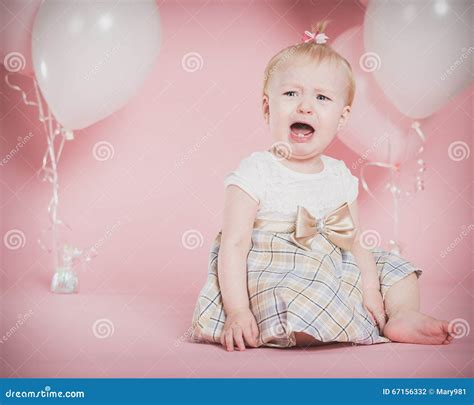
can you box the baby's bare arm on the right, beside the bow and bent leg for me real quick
[349,200,385,332]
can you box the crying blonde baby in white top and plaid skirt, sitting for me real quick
[193,22,453,351]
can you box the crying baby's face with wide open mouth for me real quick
[263,60,350,160]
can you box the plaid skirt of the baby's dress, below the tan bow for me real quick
[191,228,422,347]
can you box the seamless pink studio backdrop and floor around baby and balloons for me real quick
[0,1,474,377]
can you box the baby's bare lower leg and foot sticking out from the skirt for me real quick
[383,273,454,345]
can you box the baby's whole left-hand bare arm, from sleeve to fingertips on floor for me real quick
[217,184,258,351]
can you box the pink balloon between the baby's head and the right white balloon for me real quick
[332,26,421,164]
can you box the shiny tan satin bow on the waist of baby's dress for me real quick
[290,203,356,250]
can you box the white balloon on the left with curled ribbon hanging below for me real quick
[32,0,160,130]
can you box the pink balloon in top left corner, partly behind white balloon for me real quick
[0,0,41,76]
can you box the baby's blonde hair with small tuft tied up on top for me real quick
[263,20,356,106]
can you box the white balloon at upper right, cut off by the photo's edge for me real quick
[364,0,474,118]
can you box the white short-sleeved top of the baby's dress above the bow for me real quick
[224,151,359,220]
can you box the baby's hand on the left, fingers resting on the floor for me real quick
[221,308,258,352]
